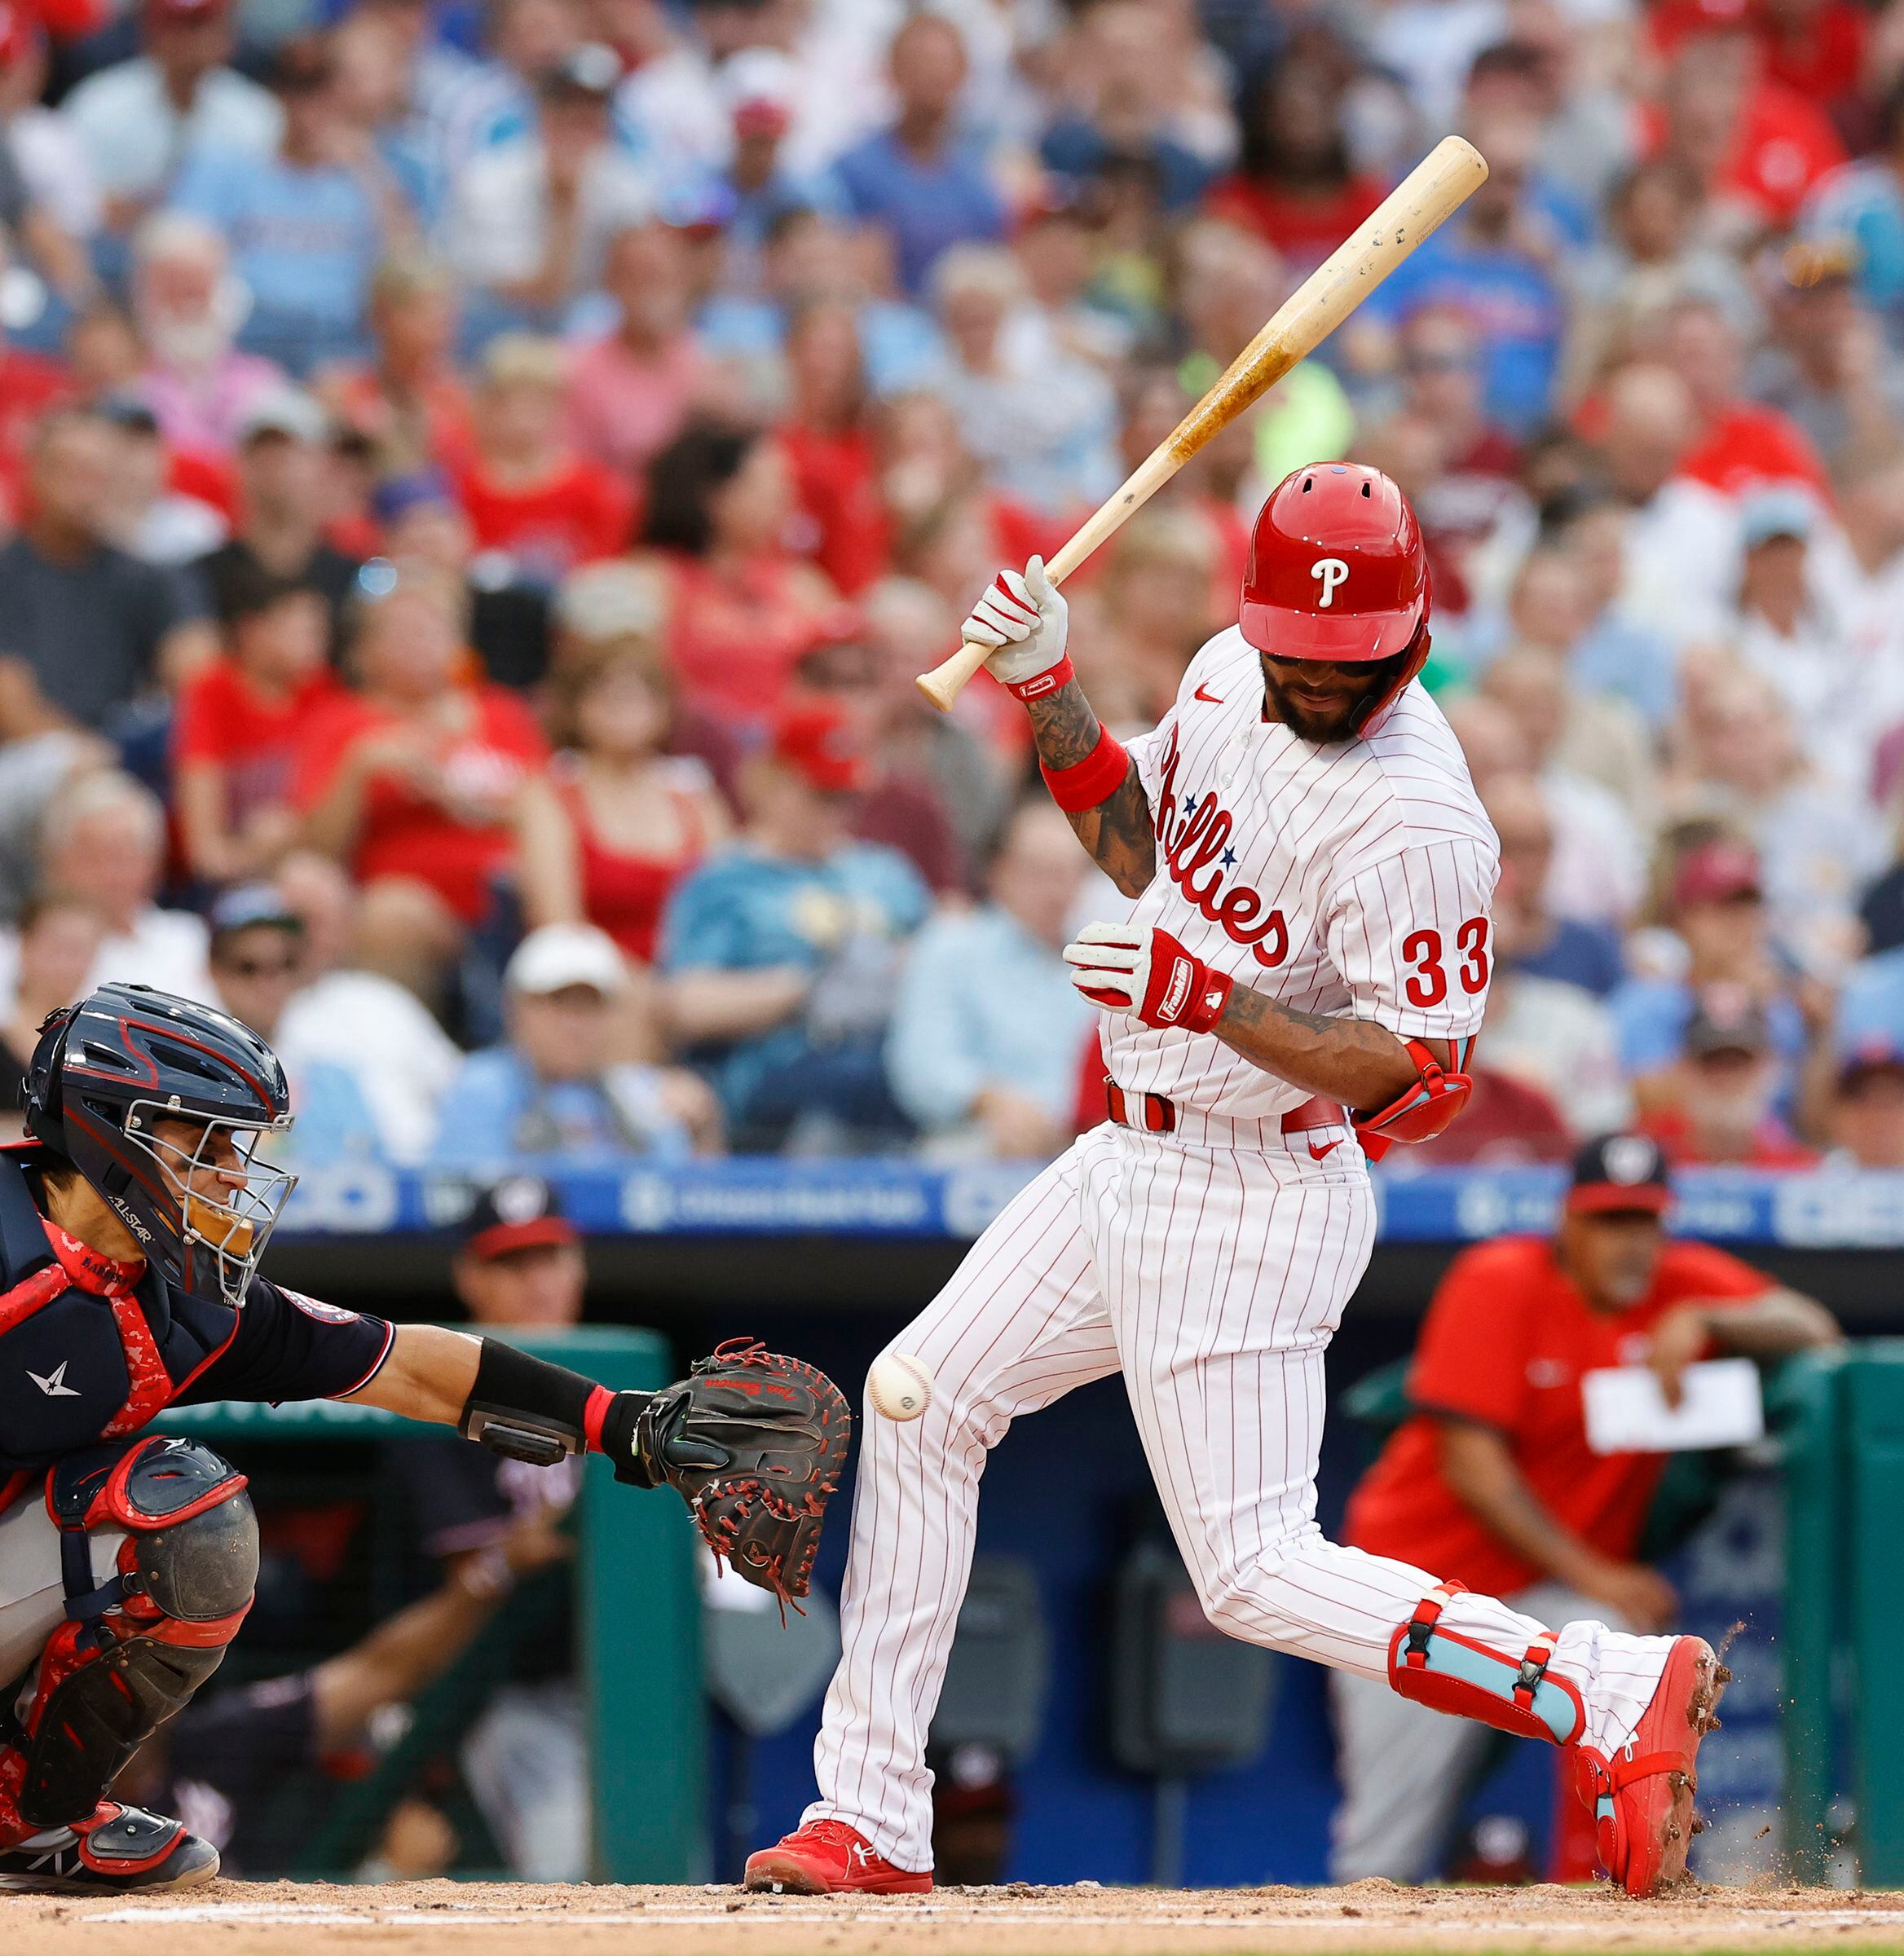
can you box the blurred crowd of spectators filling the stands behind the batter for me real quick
[11,0,1904,1172]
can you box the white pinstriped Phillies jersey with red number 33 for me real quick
[1104,628,1499,1121]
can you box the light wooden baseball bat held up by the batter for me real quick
[918,135,1488,712]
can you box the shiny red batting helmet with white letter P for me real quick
[1236,461,1429,725]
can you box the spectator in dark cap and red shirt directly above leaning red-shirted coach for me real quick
[1640,984,1818,1168]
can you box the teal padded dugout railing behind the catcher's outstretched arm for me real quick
[155,1328,710,1882]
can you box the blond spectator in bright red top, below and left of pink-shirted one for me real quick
[456,333,632,587]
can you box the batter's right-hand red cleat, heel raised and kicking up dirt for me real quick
[1577,1637,1732,1896]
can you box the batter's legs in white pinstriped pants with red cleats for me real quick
[747,1126,1722,1889]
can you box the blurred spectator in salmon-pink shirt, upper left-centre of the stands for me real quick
[570,223,707,478]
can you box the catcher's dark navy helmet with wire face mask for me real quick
[25,984,298,1306]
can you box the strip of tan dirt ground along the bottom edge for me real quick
[11,1882,1904,1956]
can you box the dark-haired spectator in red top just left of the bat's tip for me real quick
[1204,53,1382,272]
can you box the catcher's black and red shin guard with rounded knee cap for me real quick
[0,1438,258,1840]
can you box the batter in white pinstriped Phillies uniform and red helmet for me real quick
[747,464,1728,1896]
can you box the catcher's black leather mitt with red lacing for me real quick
[634,1338,853,1602]
